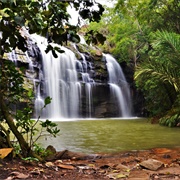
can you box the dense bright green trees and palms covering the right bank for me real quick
[86,0,180,126]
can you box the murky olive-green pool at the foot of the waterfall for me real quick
[40,119,180,153]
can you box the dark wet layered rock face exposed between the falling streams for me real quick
[4,35,141,118]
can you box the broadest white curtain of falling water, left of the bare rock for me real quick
[34,35,81,118]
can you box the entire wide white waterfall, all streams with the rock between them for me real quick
[6,34,131,120]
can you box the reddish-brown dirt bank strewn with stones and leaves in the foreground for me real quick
[0,147,180,180]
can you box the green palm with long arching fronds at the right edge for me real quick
[134,31,180,126]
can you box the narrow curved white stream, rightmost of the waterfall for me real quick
[105,54,132,117]
